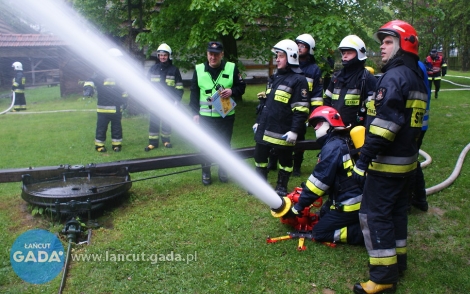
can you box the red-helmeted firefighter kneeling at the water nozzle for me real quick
[284,106,364,245]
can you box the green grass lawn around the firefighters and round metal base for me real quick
[0,71,470,293]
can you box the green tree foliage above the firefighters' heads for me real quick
[73,0,470,69]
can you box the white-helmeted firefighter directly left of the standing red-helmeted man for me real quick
[323,35,377,127]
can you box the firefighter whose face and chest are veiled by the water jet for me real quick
[90,48,127,152]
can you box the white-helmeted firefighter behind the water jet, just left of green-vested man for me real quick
[145,43,184,151]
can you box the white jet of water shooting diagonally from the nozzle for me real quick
[12,0,287,212]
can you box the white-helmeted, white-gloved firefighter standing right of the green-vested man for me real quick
[253,40,310,196]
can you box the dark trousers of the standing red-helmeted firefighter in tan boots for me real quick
[359,173,413,284]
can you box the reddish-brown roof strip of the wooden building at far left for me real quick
[0,34,65,47]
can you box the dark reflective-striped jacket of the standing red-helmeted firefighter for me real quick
[361,55,428,176]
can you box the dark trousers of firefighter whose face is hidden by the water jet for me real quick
[95,112,122,146]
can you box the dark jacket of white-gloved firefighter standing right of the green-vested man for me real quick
[255,68,310,147]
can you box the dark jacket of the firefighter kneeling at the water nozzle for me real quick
[295,132,362,212]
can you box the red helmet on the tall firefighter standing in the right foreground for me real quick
[374,20,418,56]
